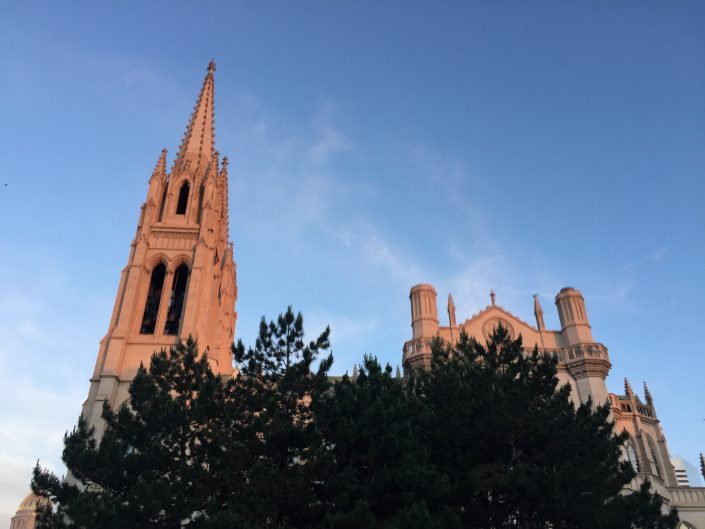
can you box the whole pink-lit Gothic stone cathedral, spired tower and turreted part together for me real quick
[10,62,705,529]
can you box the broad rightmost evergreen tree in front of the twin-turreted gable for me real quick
[412,327,677,529]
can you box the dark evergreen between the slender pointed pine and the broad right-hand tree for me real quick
[312,356,442,529]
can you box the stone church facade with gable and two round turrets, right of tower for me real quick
[402,284,705,529]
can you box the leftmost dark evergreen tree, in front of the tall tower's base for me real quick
[32,339,242,529]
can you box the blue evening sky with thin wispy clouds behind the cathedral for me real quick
[0,1,705,523]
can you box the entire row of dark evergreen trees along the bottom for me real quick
[32,308,678,529]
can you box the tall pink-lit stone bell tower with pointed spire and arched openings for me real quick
[82,61,237,436]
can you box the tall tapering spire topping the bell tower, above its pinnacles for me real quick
[174,61,215,169]
